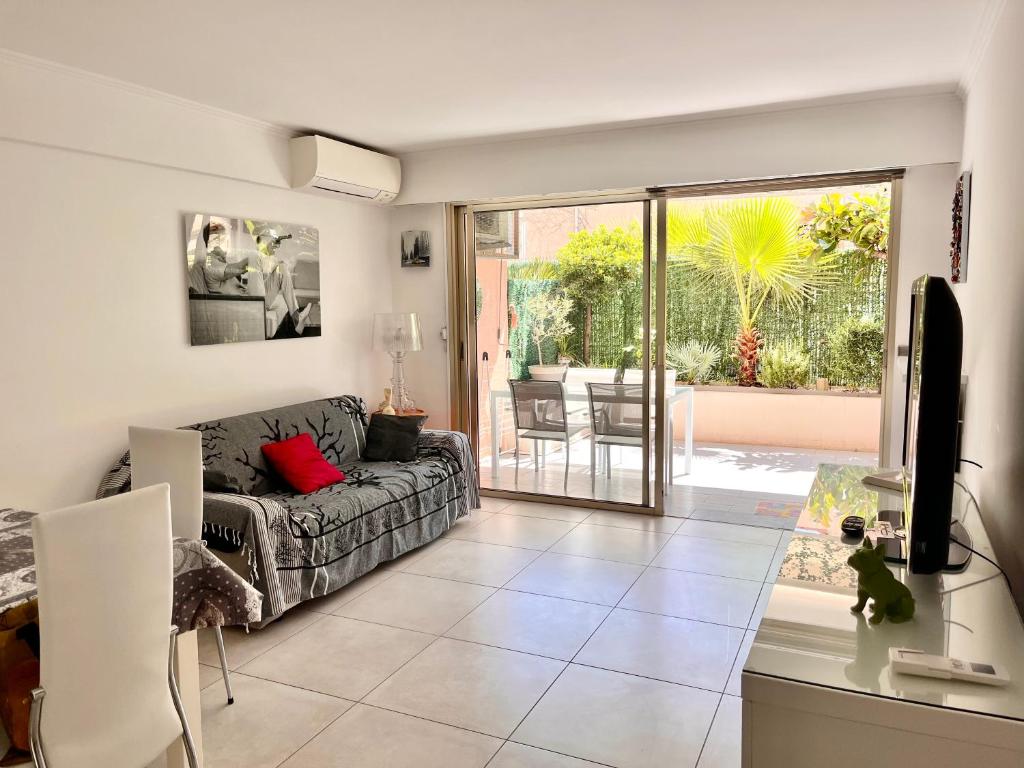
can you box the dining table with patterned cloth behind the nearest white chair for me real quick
[0,509,263,768]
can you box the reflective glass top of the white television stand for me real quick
[743,465,1024,720]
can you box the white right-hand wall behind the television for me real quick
[956,0,1024,611]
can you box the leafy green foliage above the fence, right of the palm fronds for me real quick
[803,190,890,276]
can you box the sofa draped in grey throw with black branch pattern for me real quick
[96,395,479,626]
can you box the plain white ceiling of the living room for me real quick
[0,0,991,152]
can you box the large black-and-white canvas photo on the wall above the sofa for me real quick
[184,213,321,346]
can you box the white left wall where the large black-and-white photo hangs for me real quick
[0,54,391,510]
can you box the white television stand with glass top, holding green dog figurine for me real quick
[740,465,1024,768]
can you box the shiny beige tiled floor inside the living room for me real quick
[200,499,788,768]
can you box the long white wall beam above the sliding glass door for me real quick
[398,94,963,203]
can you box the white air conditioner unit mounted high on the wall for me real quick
[291,136,401,203]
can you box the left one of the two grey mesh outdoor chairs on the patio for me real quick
[509,379,587,494]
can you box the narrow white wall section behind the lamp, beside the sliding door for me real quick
[387,204,451,429]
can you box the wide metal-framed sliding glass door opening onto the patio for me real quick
[452,171,900,522]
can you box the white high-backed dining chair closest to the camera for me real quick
[29,484,199,768]
